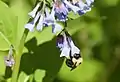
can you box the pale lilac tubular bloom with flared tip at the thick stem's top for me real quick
[24,12,40,32]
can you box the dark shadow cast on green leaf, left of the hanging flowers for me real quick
[20,38,64,82]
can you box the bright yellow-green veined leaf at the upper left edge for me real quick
[0,1,17,50]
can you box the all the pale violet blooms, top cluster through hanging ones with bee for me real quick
[25,0,94,69]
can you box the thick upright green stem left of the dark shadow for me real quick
[11,29,29,82]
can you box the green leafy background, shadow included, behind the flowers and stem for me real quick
[0,0,120,82]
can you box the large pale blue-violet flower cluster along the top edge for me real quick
[25,0,94,33]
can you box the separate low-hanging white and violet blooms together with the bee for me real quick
[57,30,83,70]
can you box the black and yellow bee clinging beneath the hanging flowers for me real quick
[66,53,83,71]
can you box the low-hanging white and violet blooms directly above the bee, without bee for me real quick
[57,30,80,58]
